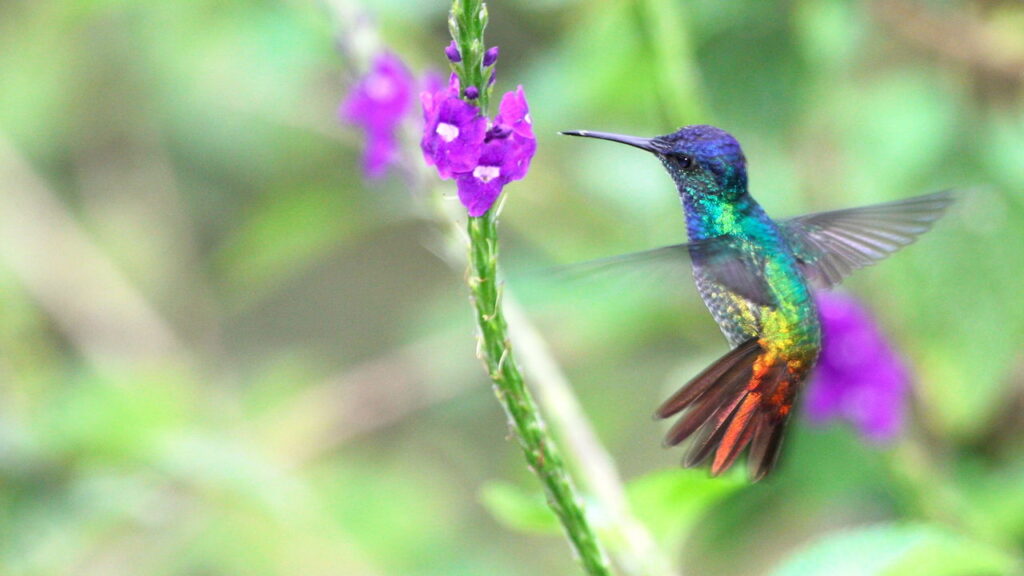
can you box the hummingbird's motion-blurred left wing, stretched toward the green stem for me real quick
[554,236,774,305]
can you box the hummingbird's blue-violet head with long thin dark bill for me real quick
[562,125,746,200]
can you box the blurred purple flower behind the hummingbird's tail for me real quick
[806,292,910,442]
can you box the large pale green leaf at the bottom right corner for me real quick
[772,524,1019,576]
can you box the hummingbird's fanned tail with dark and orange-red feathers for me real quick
[654,338,804,482]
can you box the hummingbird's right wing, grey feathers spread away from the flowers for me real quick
[779,191,955,288]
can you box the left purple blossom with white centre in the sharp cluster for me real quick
[420,74,487,178]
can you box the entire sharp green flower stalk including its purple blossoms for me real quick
[421,0,610,575]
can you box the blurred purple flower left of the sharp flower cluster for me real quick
[338,52,413,177]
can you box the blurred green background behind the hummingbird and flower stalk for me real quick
[0,0,1024,576]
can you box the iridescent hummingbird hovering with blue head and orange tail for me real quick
[562,125,954,482]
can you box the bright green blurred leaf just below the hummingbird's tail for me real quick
[627,468,748,548]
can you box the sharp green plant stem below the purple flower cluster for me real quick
[468,210,611,575]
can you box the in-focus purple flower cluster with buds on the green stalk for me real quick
[420,44,537,217]
